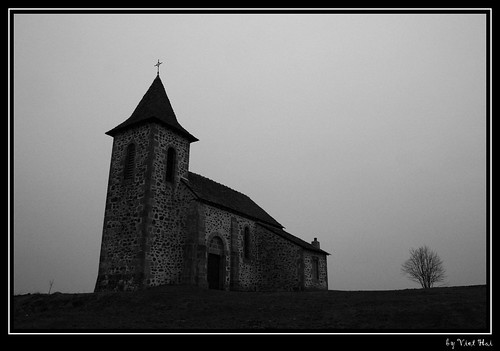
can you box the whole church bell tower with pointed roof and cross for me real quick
[95,67,198,291]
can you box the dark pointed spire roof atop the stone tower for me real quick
[106,75,198,142]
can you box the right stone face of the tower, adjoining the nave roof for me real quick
[145,124,194,286]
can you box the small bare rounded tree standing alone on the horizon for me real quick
[401,246,445,289]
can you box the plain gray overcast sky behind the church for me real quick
[11,14,486,293]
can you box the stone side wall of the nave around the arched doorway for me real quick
[186,204,328,291]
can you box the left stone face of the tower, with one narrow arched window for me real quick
[96,125,151,291]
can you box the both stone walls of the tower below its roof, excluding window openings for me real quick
[96,123,194,290]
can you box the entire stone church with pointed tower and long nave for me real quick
[95,73,329,291]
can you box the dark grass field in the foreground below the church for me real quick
[10,285,490,333]
